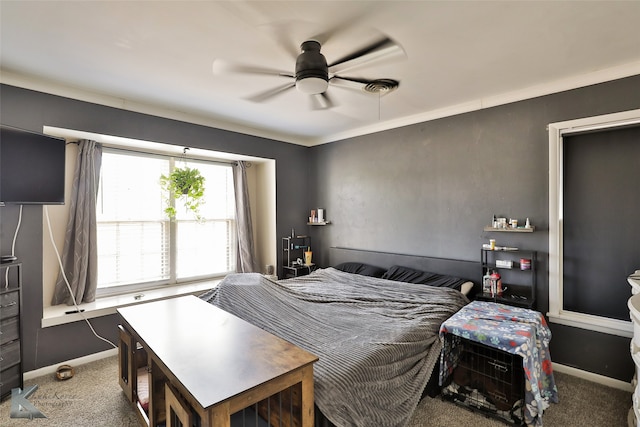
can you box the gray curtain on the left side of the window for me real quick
[51,140,102,305]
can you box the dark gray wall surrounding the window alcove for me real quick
[0,85,310,371]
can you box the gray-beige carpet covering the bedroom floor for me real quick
[0,356,632,427]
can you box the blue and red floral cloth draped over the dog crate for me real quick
[439,301,558,426]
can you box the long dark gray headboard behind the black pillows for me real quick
[329,247,482,286]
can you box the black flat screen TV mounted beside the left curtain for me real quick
[0,125,66,205]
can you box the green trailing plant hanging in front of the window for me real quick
[160,166,204,220]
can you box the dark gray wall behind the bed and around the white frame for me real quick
[310,76,640,381]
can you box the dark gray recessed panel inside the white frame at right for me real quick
[562,126,640,320]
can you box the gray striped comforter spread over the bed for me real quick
[201,268,469,427]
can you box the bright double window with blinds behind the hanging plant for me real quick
[97,148,236,295]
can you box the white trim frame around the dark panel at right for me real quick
[547,109,640,337]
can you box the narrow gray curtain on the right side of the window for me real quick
[233,162,257,273]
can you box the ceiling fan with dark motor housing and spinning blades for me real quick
[213,37,404,109]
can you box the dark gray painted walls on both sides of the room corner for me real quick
[0,76,640,381]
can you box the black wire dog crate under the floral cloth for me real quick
[442,334,525,426]
